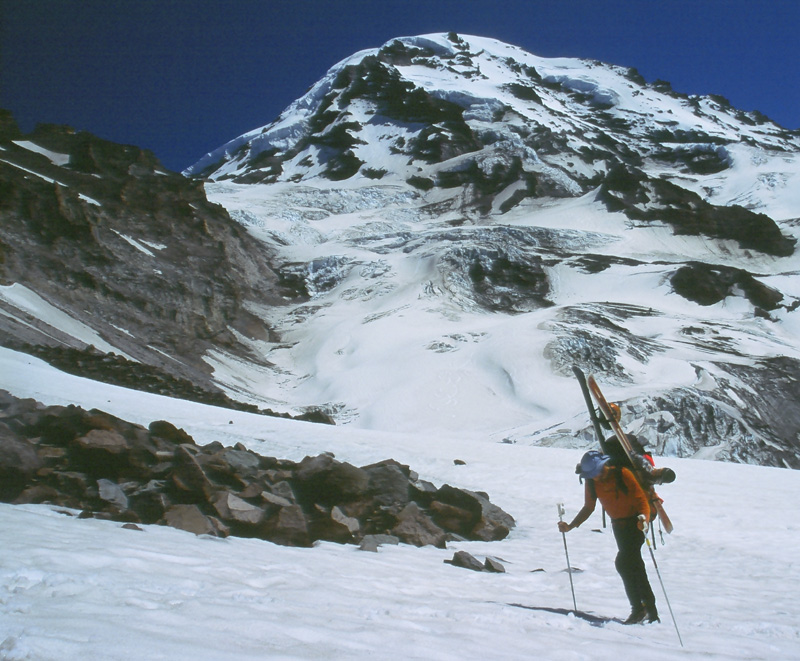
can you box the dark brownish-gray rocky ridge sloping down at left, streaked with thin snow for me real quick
[0,125,290,402]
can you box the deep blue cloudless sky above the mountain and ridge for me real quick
[0,0,800,170]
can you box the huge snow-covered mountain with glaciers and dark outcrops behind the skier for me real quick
[0,33,800,467]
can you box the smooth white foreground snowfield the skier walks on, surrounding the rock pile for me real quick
[0,349,800,661]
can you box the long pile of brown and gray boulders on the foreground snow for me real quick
[0,391,514,548]
